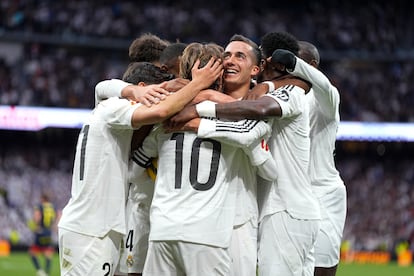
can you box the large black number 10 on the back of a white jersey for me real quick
[171,133,221,191]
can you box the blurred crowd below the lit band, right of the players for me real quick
[337,154,414,253]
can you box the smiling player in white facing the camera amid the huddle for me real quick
[179,34,266,276]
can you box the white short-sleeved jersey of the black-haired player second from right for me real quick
[258,85,320,219]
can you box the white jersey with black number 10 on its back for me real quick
[133,118,270,247]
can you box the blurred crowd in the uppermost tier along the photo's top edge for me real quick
[0,0,414,49]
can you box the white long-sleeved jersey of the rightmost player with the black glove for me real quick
[292,58,344,196]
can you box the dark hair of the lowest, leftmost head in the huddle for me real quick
[122,62,174,84]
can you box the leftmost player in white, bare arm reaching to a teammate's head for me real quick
[59,59,222,275]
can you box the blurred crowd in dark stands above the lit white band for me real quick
[0,0,414,122]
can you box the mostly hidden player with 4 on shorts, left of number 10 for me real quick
[105,62,174,275]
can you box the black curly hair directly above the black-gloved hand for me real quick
[260,32,299,58]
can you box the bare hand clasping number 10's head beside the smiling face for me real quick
[191,57,223,88]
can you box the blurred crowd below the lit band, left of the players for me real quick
[0,145,73,245]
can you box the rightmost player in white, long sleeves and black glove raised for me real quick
[272,41,347,276]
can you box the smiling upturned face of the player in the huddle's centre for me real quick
[223,41,259,88]
